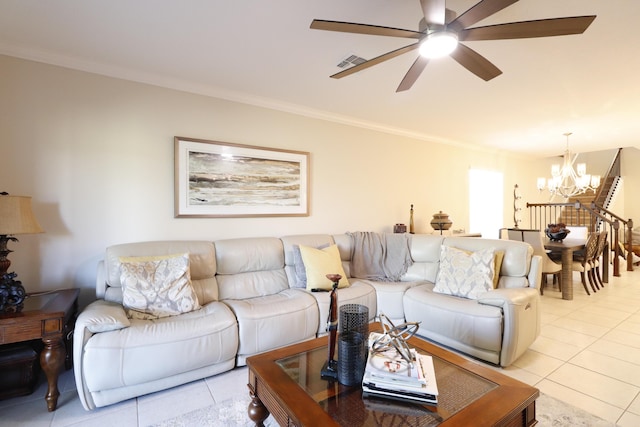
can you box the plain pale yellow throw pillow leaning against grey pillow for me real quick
[300,245,349,290]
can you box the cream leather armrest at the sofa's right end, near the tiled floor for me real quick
[478,287,540,367]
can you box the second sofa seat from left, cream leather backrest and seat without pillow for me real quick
[214,237,319,365]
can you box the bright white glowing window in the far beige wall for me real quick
[469,169,504,239]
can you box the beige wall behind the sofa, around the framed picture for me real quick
[0,56,632,304]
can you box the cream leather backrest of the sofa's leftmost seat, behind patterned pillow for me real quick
[101,240,218,304]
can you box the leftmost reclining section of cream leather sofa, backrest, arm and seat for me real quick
[73,241,238,410]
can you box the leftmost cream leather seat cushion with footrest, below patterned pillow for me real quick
[81,302,238,392]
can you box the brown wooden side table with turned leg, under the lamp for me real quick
[0,289,80,412]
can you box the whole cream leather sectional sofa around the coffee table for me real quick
[73,234,541,410]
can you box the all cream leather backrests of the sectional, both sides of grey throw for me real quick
[96,234,537,304]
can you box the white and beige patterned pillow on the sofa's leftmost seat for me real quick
[120,253,200,319]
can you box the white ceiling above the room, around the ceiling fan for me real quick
[0,0,640,157]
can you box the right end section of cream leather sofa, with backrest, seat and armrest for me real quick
[403,237,542,367]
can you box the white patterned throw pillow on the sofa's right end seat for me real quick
[433,246,495,299]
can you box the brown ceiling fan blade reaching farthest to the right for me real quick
[458,15,596,41]
